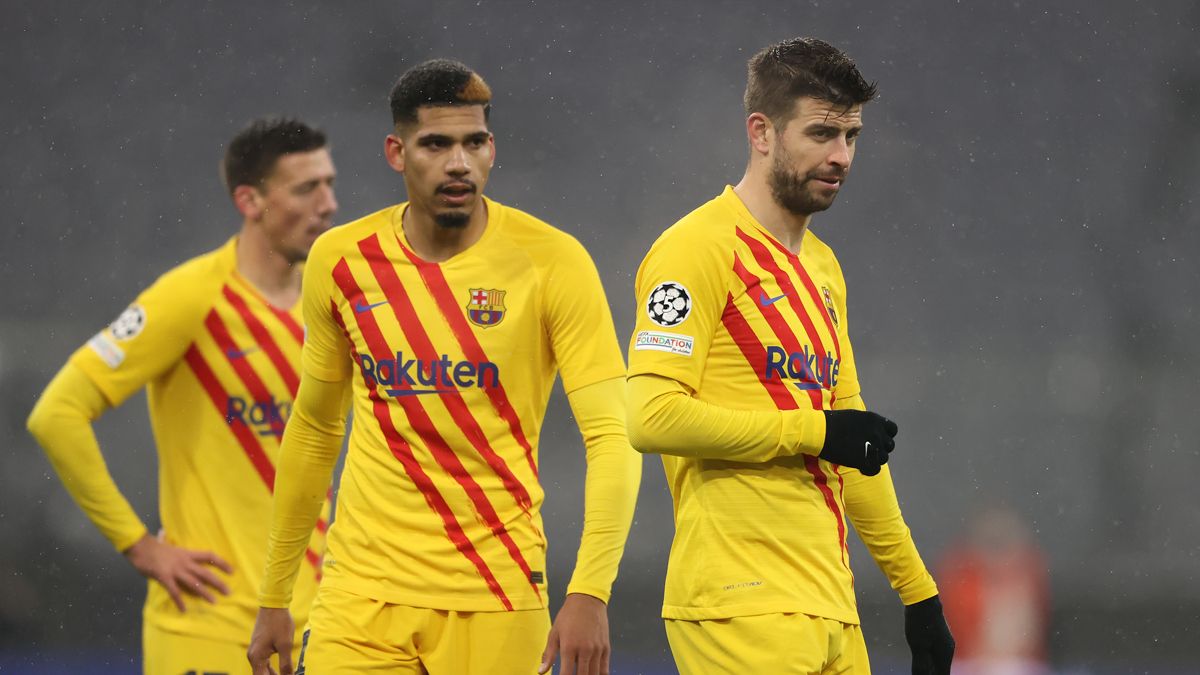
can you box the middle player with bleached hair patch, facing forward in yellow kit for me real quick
[248,60,641,675]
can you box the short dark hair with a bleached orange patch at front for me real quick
[391,59,492,130]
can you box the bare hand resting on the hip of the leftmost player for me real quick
[124,532,233,611]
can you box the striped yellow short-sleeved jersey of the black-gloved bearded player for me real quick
[629,187,859,623]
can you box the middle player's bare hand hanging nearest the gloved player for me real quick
[538,593,612,675]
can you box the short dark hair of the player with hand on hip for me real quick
[221,118,325,195]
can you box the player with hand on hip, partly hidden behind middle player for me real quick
[29,119,337,675]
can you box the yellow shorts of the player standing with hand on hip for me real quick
[142,623,300,675]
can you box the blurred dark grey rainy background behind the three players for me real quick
[0,0,1200,673]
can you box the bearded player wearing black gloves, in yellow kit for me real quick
[629,38,954,674]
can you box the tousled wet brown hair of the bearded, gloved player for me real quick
[744,37,876,126]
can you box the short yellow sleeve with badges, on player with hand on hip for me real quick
[71,262,215,406]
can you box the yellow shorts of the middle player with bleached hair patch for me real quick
[296,586,550,675]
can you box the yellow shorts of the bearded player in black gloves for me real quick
[666,614,871,675]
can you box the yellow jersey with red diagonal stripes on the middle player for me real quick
[297,199,624,611]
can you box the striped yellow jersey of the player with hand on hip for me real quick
[71,238,329,643]
